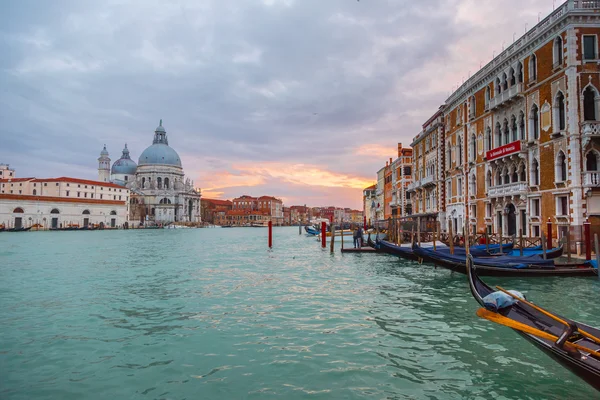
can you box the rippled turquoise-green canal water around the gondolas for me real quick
[0,227,600,400]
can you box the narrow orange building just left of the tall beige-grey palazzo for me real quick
[390,143,413,217]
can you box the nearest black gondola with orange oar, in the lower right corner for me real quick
[467,259,600,391]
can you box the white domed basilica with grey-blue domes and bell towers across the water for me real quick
[98,120,201,224]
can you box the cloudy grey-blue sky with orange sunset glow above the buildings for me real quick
[0,0,560,209]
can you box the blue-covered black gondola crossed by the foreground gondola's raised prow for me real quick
[413,244,598,276]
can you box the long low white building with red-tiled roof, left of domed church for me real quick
[0,164,130,229]
